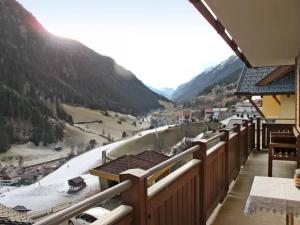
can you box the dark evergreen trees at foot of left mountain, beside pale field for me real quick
[0,84,72,152]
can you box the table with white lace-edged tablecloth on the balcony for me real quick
[245,176,300,225]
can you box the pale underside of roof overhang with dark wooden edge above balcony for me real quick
[190,0,300,67]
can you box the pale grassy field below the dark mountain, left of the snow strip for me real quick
[0,105,146,166]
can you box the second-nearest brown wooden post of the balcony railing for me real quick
[193,140,207,225]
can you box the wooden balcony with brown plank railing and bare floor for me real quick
[36,118,300,225]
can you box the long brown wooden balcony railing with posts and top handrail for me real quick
[36,120,255,225]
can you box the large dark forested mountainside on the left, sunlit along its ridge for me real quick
[0,0,168,151]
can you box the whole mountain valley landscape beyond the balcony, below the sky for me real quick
[0,0,253,223]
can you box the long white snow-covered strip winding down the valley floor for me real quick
[0,126,168,213]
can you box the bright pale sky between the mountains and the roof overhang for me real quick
[18,0,233,88]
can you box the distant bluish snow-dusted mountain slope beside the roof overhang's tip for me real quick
[171,56,244,104]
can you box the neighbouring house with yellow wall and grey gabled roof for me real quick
[235,66,296,118]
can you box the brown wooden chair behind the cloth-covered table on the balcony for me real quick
[268,128,300,177]
